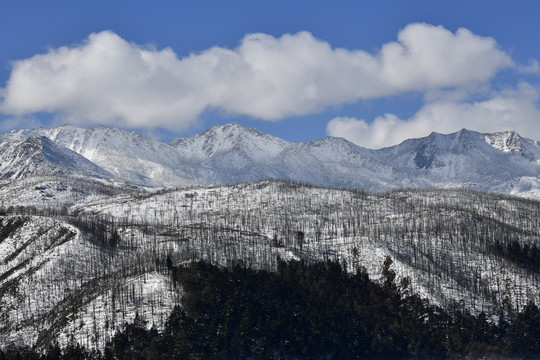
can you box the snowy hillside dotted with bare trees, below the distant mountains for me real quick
[0,178,540,348]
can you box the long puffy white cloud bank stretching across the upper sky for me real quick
[0,24,512,129]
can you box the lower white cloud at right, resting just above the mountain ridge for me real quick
[326,83,540,148]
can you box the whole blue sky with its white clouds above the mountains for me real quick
[0,1,540,148]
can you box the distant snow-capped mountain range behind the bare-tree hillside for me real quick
[0,123,540,198]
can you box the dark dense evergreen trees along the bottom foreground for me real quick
[6,259,540,360]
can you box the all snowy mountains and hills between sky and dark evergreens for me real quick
[0,124,540,349]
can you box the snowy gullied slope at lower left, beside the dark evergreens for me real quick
[0,215,179,348]
